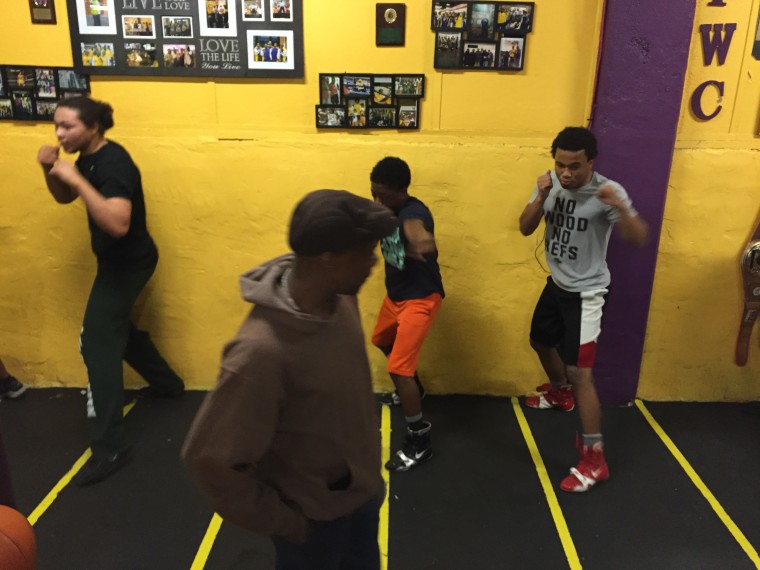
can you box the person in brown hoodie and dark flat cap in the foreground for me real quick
[182,190,398,570]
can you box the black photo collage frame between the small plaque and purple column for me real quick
[430,0,535,71]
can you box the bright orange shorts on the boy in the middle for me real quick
[372,293,442,376]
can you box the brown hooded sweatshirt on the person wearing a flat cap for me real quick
[182,254,383,536]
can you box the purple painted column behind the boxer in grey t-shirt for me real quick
[591,0,696,405]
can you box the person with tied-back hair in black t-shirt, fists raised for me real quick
[37,97,185,485]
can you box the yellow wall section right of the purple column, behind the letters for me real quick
[639,0,760,400]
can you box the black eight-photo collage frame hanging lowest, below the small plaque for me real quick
[316,73,425,130]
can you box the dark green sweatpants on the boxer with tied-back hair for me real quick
[79,255,184,455]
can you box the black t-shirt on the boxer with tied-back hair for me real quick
[77,141,157,263]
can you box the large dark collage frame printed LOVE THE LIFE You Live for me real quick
[67,0,304,78]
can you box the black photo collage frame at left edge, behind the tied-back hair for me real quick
[0,65,90,121]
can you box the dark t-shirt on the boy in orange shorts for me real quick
[380,196,445,301]
